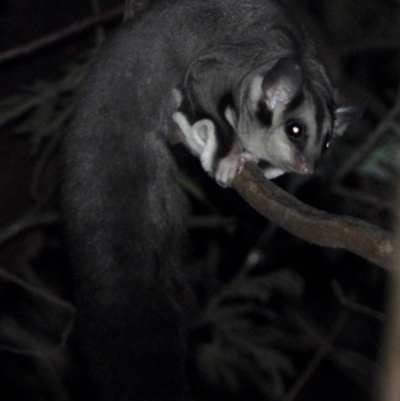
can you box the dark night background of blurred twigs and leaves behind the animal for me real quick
[0,0,400,401]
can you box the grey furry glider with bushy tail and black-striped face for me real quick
[63,0,356,401]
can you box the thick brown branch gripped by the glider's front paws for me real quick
[232,163,393,269]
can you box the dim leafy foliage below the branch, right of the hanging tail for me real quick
[196,270,303,400]
